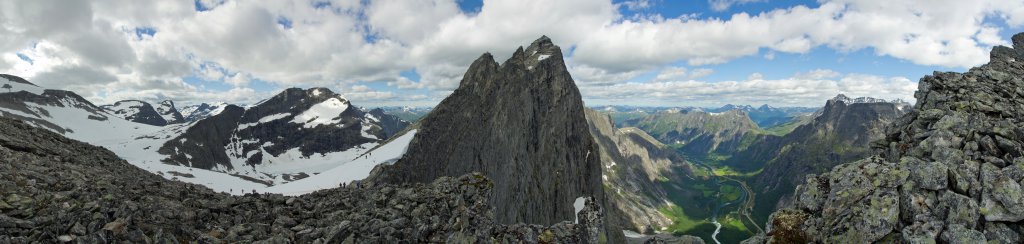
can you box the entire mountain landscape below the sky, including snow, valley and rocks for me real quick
[0,33,1024,243]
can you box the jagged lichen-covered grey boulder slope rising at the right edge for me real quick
[749,33,1024,243]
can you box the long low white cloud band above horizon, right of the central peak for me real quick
[581,69,918,107]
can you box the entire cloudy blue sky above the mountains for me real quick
[0,0,1024,107]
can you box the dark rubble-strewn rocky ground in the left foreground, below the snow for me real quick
[0,118,603,243]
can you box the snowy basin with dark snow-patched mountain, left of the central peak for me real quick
[0,75,415,194]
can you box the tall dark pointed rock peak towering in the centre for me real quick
[370,37,604,228]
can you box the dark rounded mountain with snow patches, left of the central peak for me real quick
[159,88,408,185]
